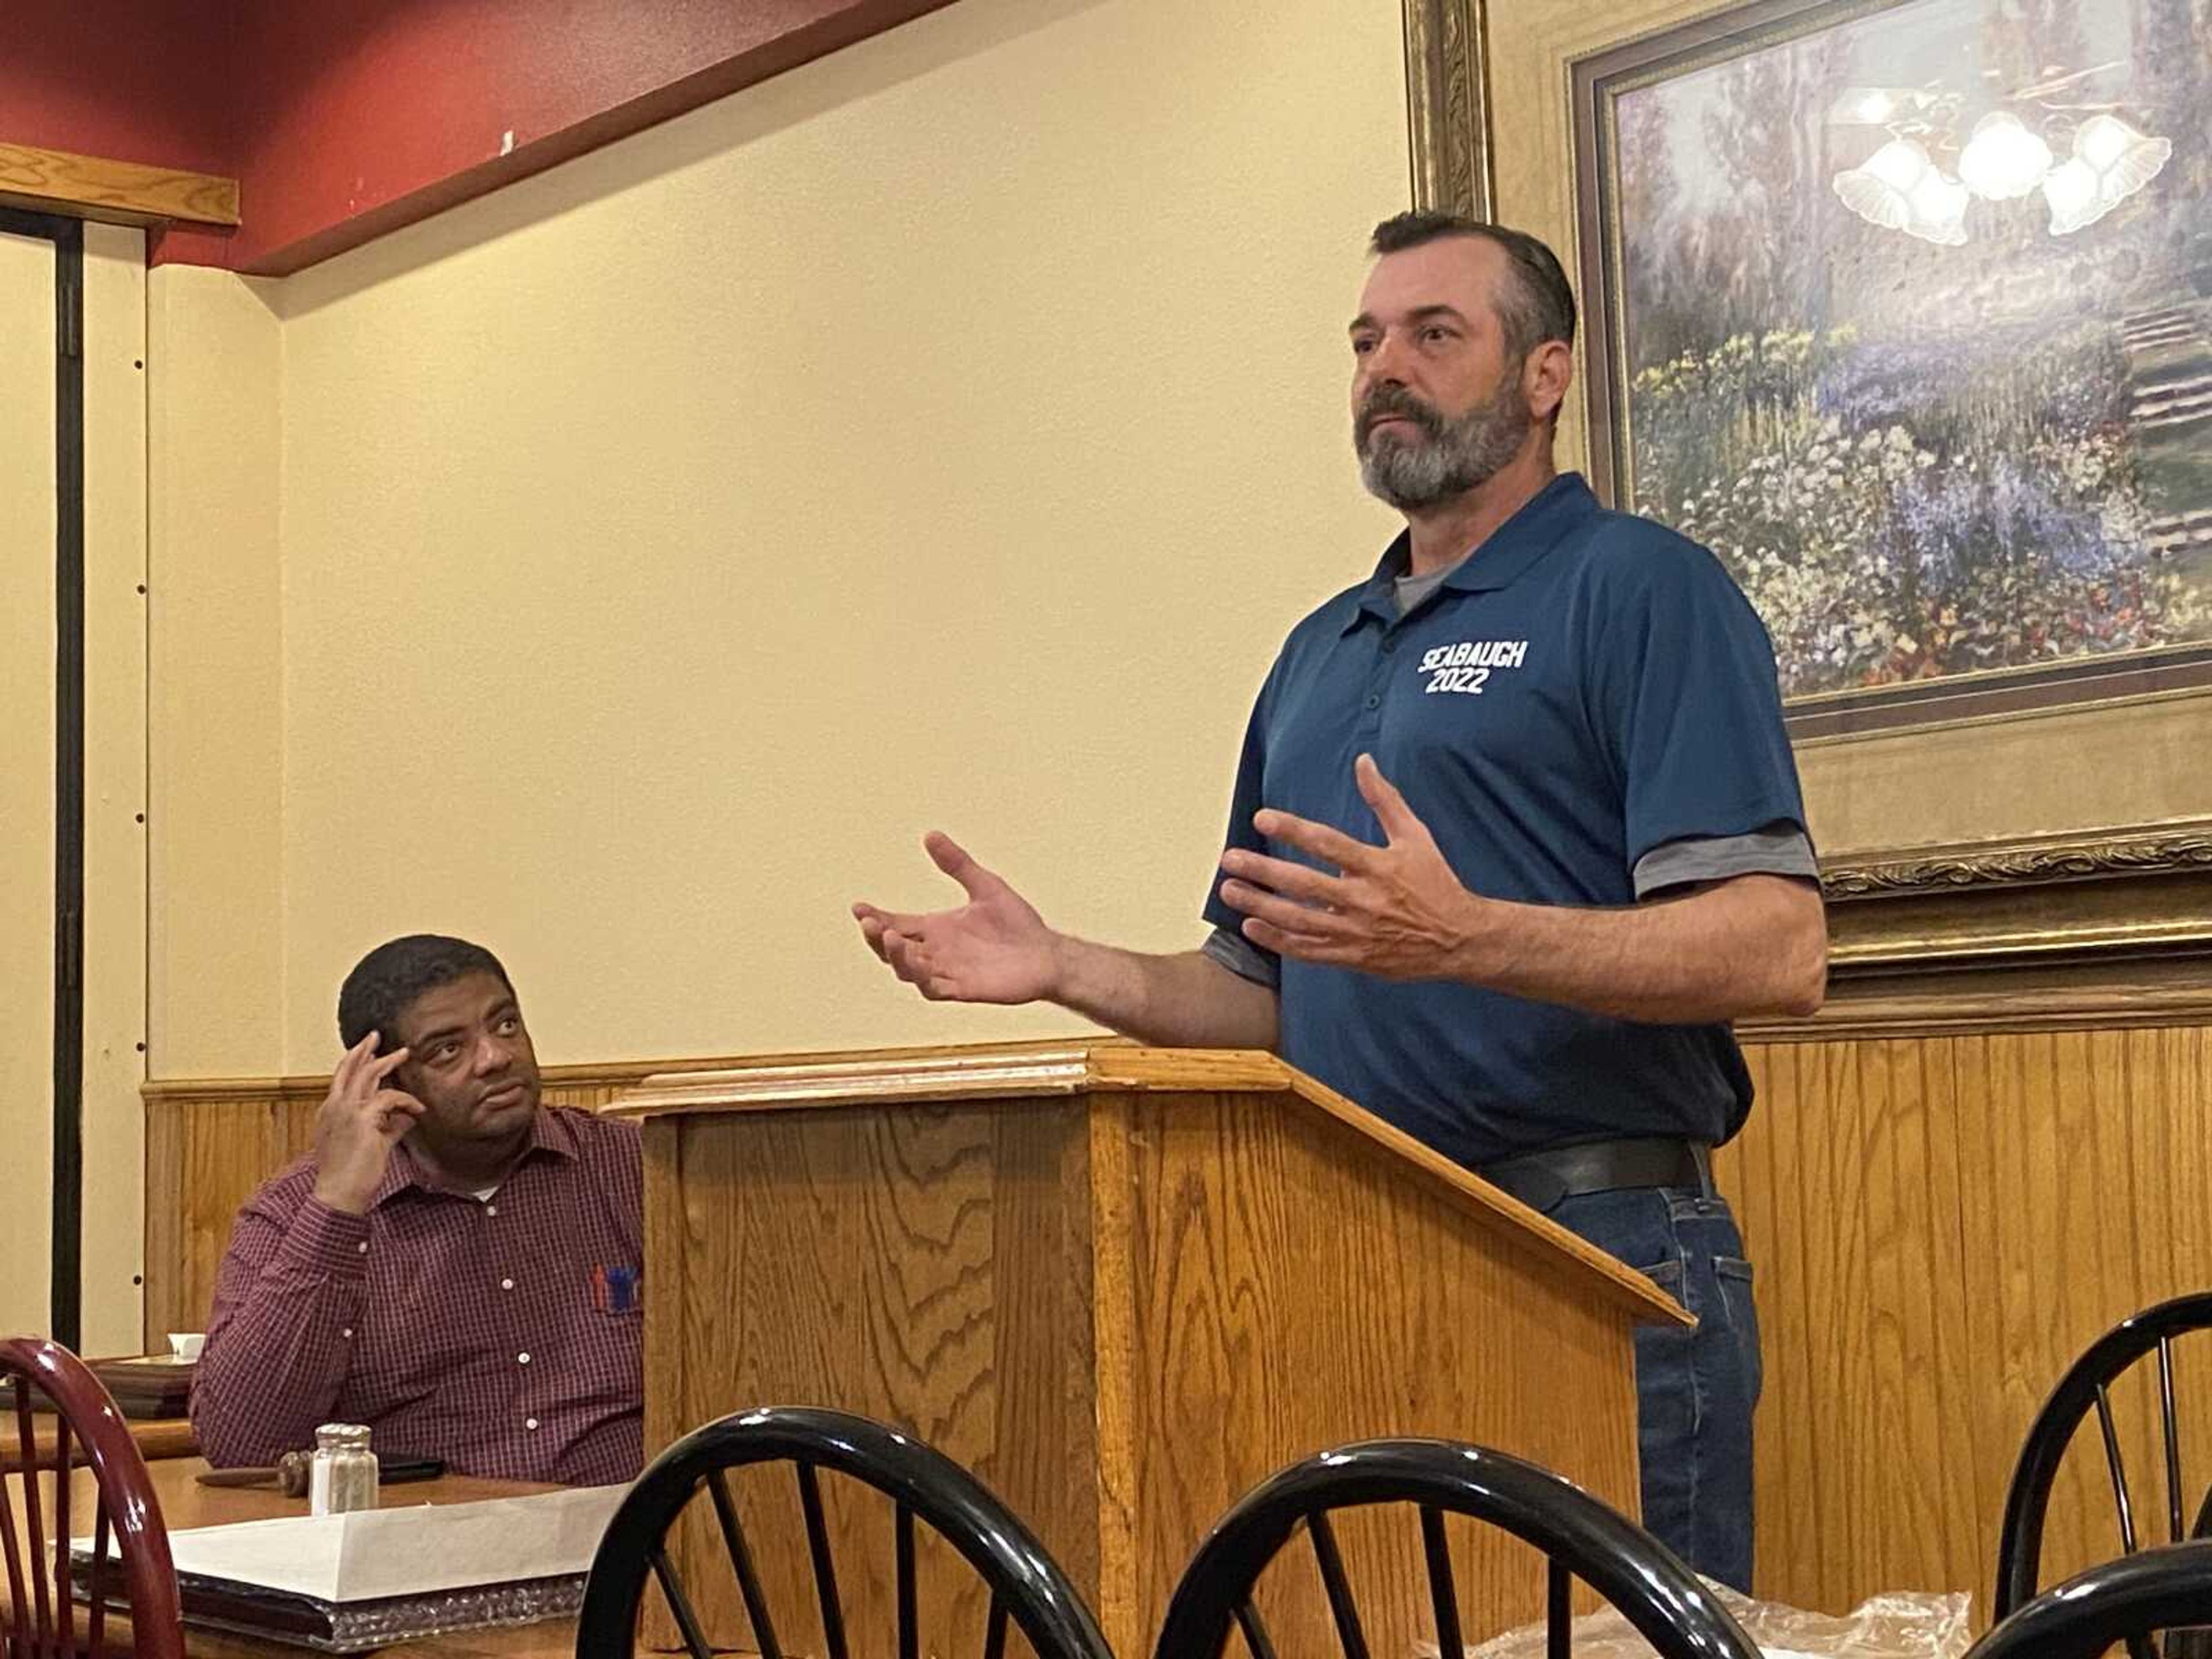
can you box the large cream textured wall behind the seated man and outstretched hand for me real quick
[267,0,1407,1071]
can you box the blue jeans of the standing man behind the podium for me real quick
[1551,1188,1761,1595]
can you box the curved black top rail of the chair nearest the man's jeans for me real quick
[1153,1440,1759,1659]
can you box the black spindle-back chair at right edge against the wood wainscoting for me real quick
[1993,1296,2212,1659]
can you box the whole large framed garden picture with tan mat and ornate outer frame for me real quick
[1403,0,2212,946]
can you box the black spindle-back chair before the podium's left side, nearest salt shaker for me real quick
[575,1407,1113,1659]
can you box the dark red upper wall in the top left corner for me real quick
[0,0,947,274]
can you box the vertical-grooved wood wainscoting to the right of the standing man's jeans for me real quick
[1719,1027,2212,1617]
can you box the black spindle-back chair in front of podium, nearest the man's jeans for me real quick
[1154,1440,1759,1659]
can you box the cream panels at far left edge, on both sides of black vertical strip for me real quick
[0,224,146,1354]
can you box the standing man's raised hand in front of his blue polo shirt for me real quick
[1221,754,1484,980]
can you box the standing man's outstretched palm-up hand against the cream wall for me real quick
[851,830,1059,1002]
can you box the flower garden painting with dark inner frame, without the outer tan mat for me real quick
[1586,0,2212,724]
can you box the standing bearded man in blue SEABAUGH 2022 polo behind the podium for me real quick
[854,213,1827,1590]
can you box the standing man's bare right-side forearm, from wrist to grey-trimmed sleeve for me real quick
[1453,876,1827,1024]
